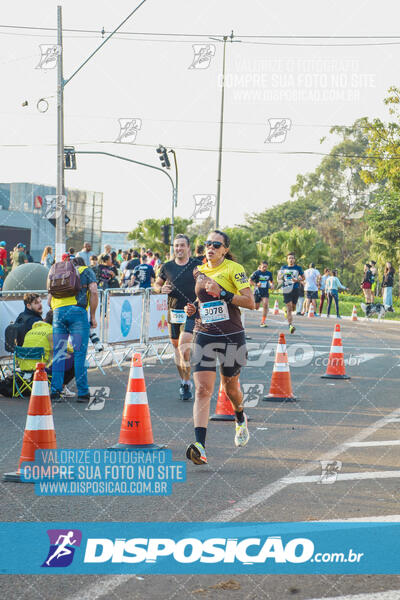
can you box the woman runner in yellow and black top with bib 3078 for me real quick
[185,230,255,465]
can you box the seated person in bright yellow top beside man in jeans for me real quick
[16,310,75,398]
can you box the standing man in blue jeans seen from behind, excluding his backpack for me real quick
[49,257,99,402]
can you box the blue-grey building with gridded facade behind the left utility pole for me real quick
[0,183,103,262]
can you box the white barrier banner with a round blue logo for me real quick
[107,295,143,343]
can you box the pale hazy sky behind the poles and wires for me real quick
[0,0,400,231]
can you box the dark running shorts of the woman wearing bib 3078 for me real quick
[191,331,247,377]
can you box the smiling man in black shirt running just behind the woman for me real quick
[154,233,201,400]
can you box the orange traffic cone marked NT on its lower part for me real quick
[110,352,165,450]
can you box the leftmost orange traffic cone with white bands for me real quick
[4,363,57,483]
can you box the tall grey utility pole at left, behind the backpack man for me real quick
[55,6,65,261]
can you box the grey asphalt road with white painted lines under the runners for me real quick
[0,314,400,600]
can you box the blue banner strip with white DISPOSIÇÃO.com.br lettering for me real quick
[0,522,400,575]
